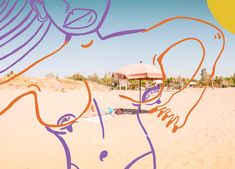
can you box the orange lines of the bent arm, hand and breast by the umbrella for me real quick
[119,16,225,132]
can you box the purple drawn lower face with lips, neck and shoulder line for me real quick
[42,0,145,41]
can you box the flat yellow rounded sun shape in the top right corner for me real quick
[207,0,235,33]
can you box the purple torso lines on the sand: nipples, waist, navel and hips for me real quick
[46,86,159,169]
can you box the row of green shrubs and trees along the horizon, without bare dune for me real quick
[69,68,235,89]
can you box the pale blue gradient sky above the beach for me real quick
[0,0,235,77]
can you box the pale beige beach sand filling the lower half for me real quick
[0,87,235,169]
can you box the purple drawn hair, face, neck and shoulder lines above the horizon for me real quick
[0,0,145,74]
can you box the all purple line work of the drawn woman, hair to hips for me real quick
[0,0,226,169]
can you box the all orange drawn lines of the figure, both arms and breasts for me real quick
[0,16,225,132]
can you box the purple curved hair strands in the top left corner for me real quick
[0,0,51,74]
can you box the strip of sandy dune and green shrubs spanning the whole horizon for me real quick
[1,68,235,90]
